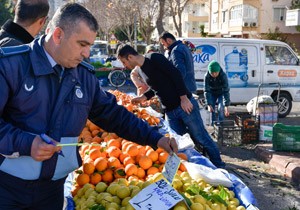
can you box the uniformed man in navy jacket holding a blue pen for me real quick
[0,3,178,210]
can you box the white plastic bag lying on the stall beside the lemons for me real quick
[183,161,233,187]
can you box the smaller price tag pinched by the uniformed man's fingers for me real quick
[162,153,180,184]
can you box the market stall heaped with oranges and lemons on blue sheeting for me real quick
[65,91,257,210]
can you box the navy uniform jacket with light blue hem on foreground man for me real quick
[0,37,162,180]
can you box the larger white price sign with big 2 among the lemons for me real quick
[129,179,183,210]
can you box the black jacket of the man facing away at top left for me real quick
[0,20,34,47]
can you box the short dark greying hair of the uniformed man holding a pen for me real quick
[49,3,99,35]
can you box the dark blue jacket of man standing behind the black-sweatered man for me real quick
[168,41,197,93]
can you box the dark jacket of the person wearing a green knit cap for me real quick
[204,69,230,106]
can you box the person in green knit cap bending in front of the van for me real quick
[204,60,230,125]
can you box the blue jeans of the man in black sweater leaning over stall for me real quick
[166,98,225,168]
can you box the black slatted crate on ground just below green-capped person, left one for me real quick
[214,120,242,146]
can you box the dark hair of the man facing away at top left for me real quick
[15,0,50,25]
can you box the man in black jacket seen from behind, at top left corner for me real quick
[0,0,49,47]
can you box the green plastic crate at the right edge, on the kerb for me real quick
[272,123,300,152]
